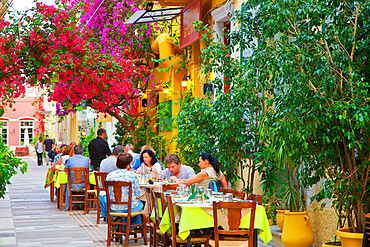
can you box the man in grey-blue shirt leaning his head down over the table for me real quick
[161,154,195,182]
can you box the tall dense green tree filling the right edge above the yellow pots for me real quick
[236,0,370,232]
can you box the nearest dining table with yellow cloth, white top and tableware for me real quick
[150,195,272,246]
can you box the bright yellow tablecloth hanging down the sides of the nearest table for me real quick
[159,204,272,244]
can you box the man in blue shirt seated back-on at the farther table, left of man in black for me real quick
[64,145,90,211]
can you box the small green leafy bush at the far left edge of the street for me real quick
[0,141,28,198]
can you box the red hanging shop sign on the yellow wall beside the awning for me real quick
[180,0,202,49]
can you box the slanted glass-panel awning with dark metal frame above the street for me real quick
[125,7,183,24]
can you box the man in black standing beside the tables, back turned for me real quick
[88,129,112,171]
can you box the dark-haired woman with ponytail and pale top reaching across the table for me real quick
[178,153,228,189]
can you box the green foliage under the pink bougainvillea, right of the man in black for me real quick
[113,107,169,161]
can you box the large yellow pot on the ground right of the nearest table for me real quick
[281,212,313,247]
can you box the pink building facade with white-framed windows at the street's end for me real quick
[0,90,44,147]
